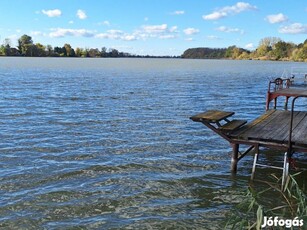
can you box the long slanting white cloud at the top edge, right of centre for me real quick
[203,2,257,20]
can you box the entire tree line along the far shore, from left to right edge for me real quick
[0,34,307,62]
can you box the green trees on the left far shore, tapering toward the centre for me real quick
[0,34,178,58]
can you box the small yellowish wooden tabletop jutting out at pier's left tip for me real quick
[190,110,234,123]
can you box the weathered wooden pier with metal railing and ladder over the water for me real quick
[190,78,307,188]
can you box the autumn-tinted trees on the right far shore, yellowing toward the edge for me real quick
[181,37,307,62]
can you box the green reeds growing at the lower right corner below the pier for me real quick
[225,173,307,230]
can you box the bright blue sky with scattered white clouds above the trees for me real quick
[0,0,307,55]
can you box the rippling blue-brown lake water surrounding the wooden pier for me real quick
[0,58,306,229]
